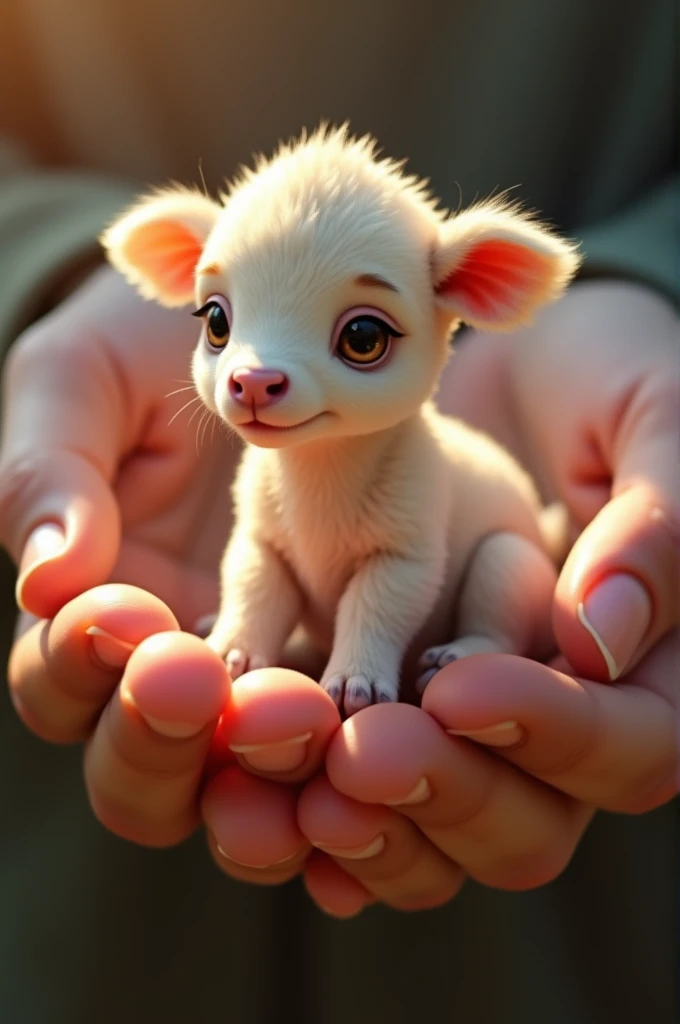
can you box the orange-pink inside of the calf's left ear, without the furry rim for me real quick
[128,220,203,296]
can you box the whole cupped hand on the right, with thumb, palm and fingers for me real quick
[209,282,680,915]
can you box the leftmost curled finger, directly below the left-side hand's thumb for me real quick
[8,584,177,743]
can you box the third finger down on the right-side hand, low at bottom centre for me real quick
[298,775,463,910]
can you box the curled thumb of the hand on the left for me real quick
[0,451,120,618]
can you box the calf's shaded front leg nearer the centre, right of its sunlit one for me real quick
[321,554,443,716]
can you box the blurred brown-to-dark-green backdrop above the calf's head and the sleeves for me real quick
[0,0,677,226]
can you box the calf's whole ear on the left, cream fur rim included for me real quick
[100,187,221,306]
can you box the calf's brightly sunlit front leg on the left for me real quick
[206,528,302,679]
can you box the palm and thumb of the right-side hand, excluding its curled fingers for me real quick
[440,281,680,681]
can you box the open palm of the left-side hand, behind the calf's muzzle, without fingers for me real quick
[34,268,239,629]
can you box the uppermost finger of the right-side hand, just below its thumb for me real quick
[421,655,680,813]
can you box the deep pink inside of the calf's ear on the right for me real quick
[436,239,550,316]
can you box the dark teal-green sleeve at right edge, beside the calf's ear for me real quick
[576,177,680,304]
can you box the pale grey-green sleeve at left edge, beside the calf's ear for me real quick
[0,140,138,353]
